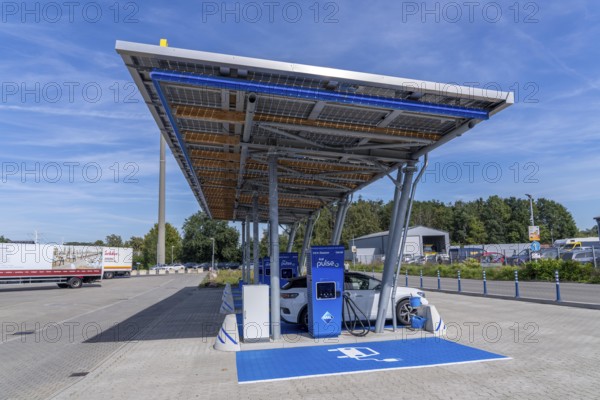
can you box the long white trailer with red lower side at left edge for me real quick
[0,243,104,288]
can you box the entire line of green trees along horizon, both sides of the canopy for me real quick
[0,196,598,267]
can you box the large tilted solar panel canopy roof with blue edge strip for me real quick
[116,41,513,223]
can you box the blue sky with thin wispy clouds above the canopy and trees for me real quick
[0,0,600,242]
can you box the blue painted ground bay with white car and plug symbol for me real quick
[236,337,509,383]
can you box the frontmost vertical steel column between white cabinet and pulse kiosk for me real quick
[269,154,281,340]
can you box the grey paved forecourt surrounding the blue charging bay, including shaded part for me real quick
[0,274,600,400]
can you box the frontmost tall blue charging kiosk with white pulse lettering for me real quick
[306,246,344,338]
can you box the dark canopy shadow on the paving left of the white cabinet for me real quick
[84,287,224,343]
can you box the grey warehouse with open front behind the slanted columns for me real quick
[353,225,450,264]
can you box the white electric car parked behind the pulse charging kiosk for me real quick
[280,272,428,327]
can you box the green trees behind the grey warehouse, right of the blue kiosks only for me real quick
[282,196,580,253]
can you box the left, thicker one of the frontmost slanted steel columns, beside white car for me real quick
[375,161,416,333]
